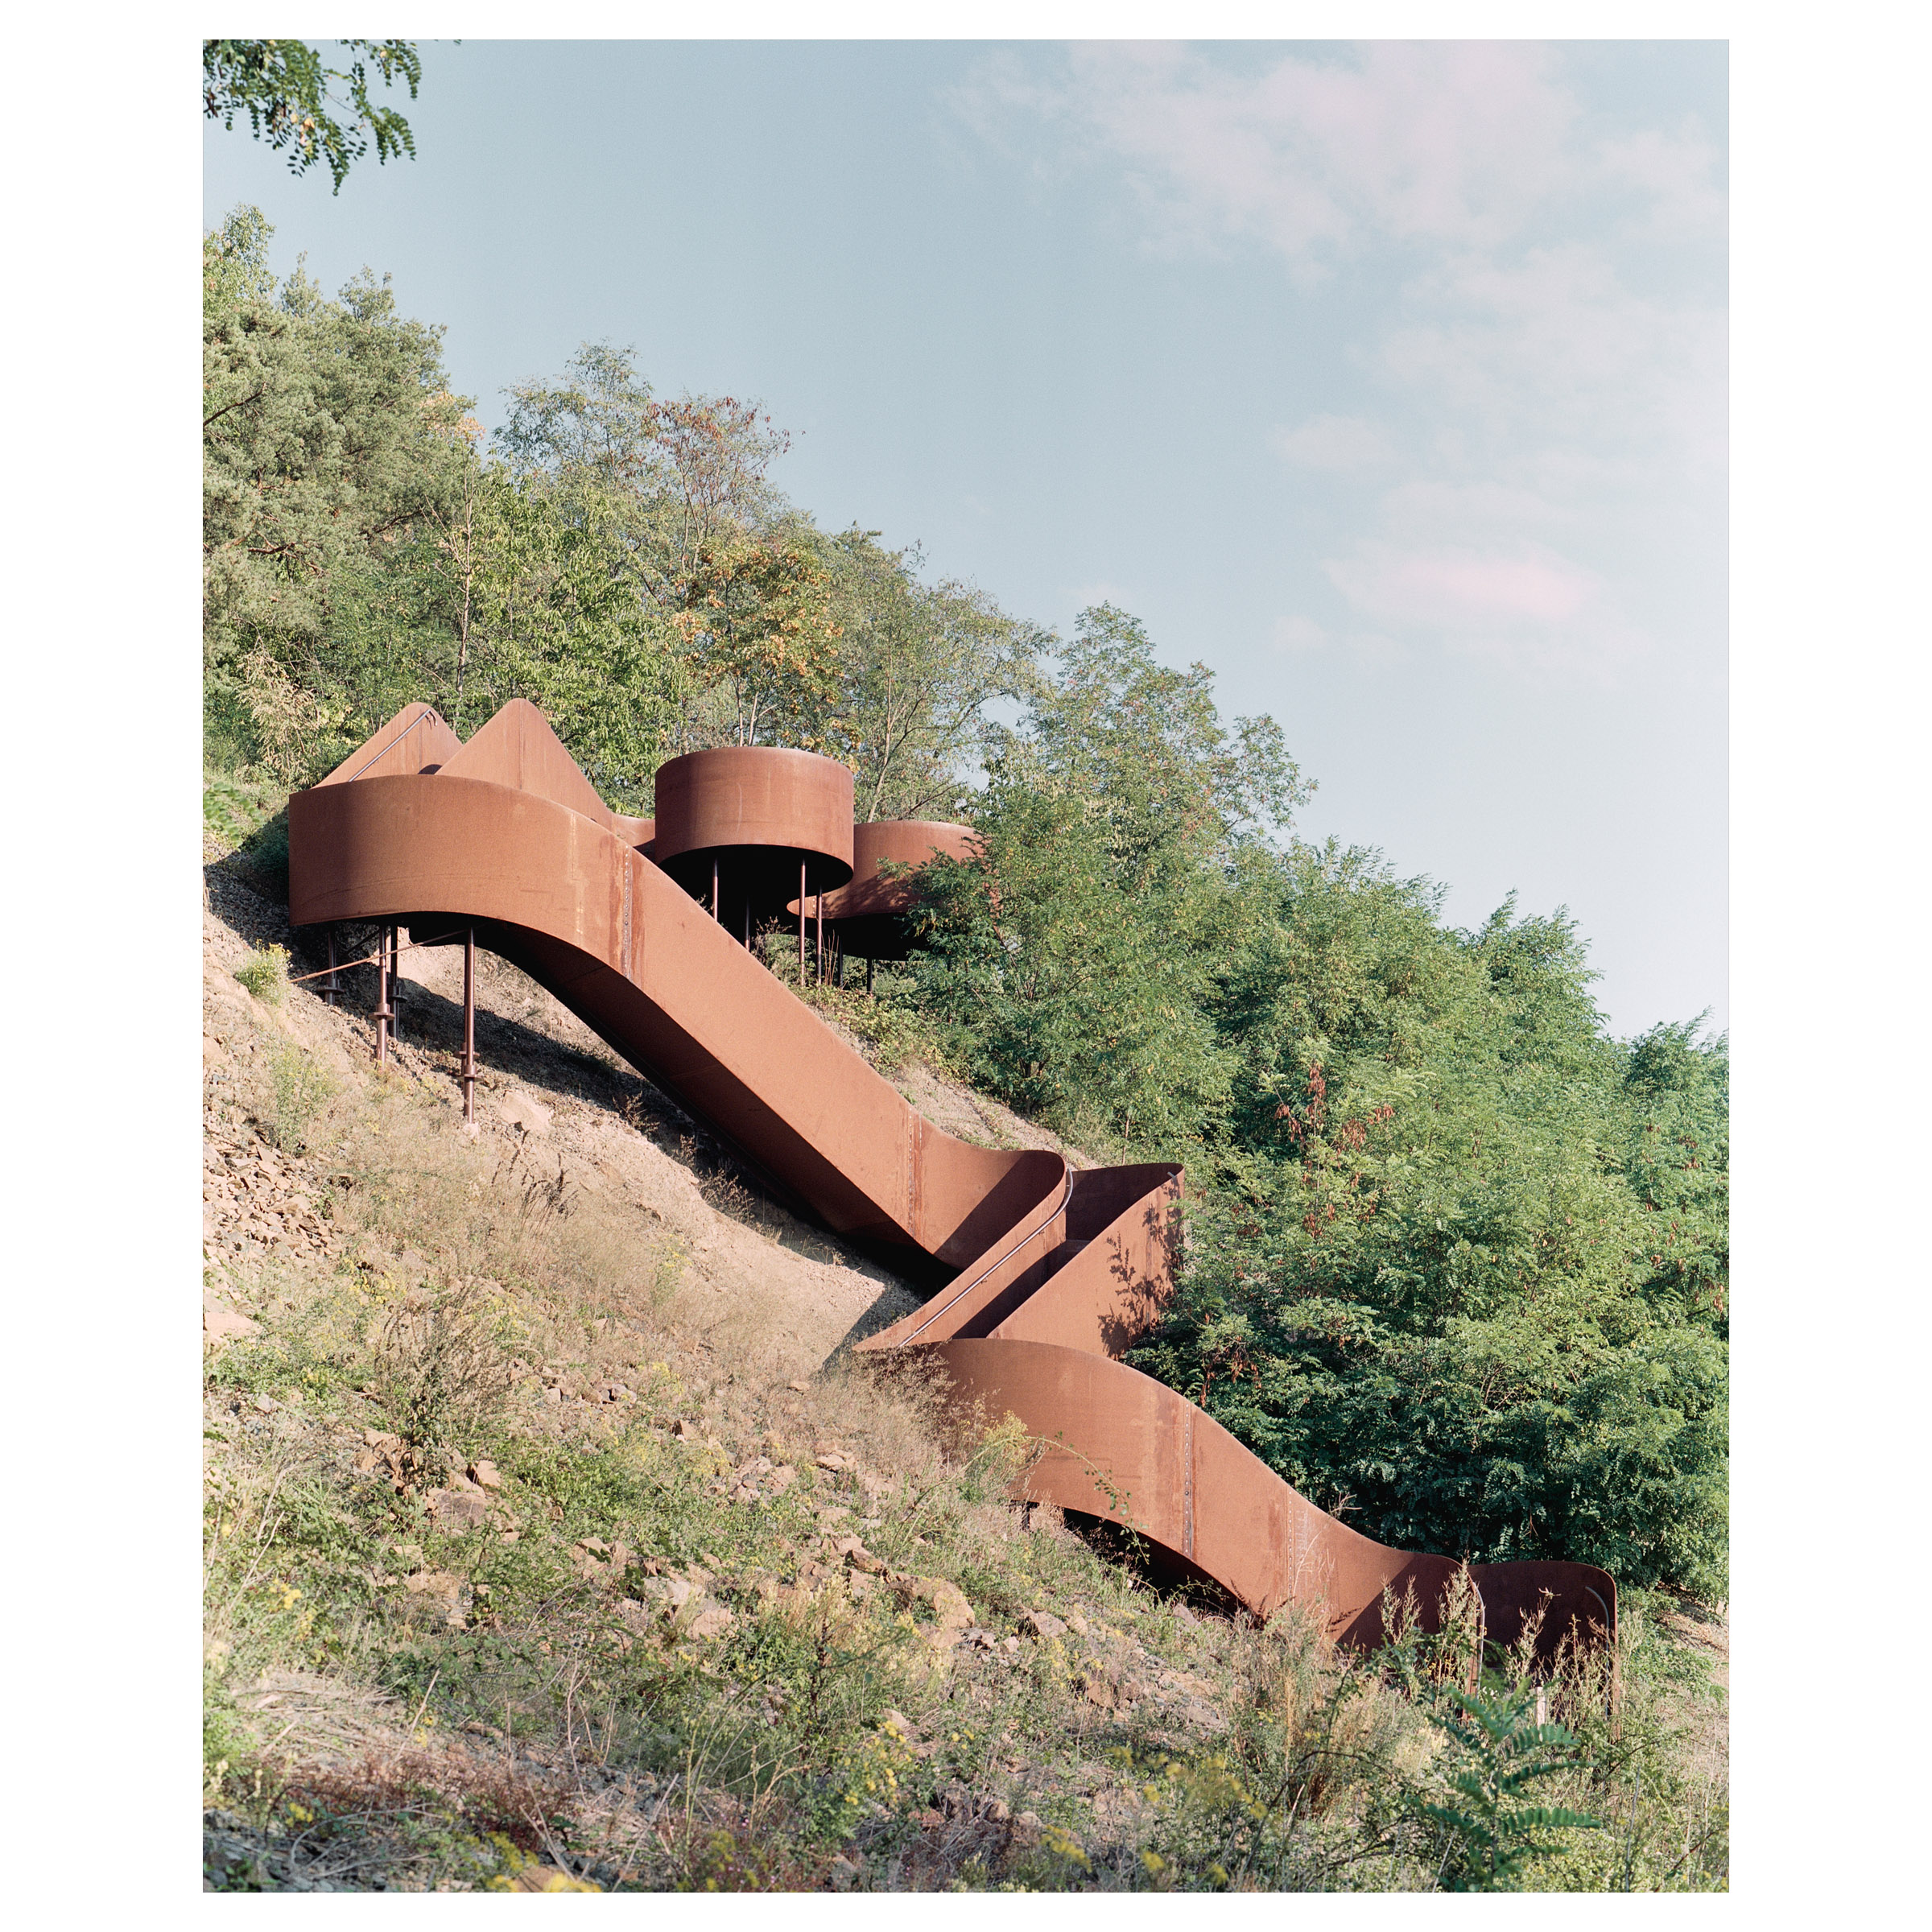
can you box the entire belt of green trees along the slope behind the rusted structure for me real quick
[203,208,1729,1594]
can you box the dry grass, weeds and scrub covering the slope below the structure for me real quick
[203,1020,1725,1889]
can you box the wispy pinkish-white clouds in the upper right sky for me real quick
[960,43,1725,675]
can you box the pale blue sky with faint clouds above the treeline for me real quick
[204,43,1728,1034]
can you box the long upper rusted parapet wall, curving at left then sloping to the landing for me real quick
[288,773,1064,1265]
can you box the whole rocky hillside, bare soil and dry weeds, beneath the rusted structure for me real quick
[203,823,1725,1889]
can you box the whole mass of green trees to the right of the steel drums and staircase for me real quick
[894,753,1728,1594]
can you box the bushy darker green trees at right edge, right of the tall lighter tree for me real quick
[1141,869,1725,1590]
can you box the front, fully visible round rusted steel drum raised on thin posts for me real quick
[651,745,852,927]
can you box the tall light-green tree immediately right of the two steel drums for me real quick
[910,605,1302,1154]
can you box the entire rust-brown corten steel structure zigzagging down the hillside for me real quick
[288,704,1617,1652]
